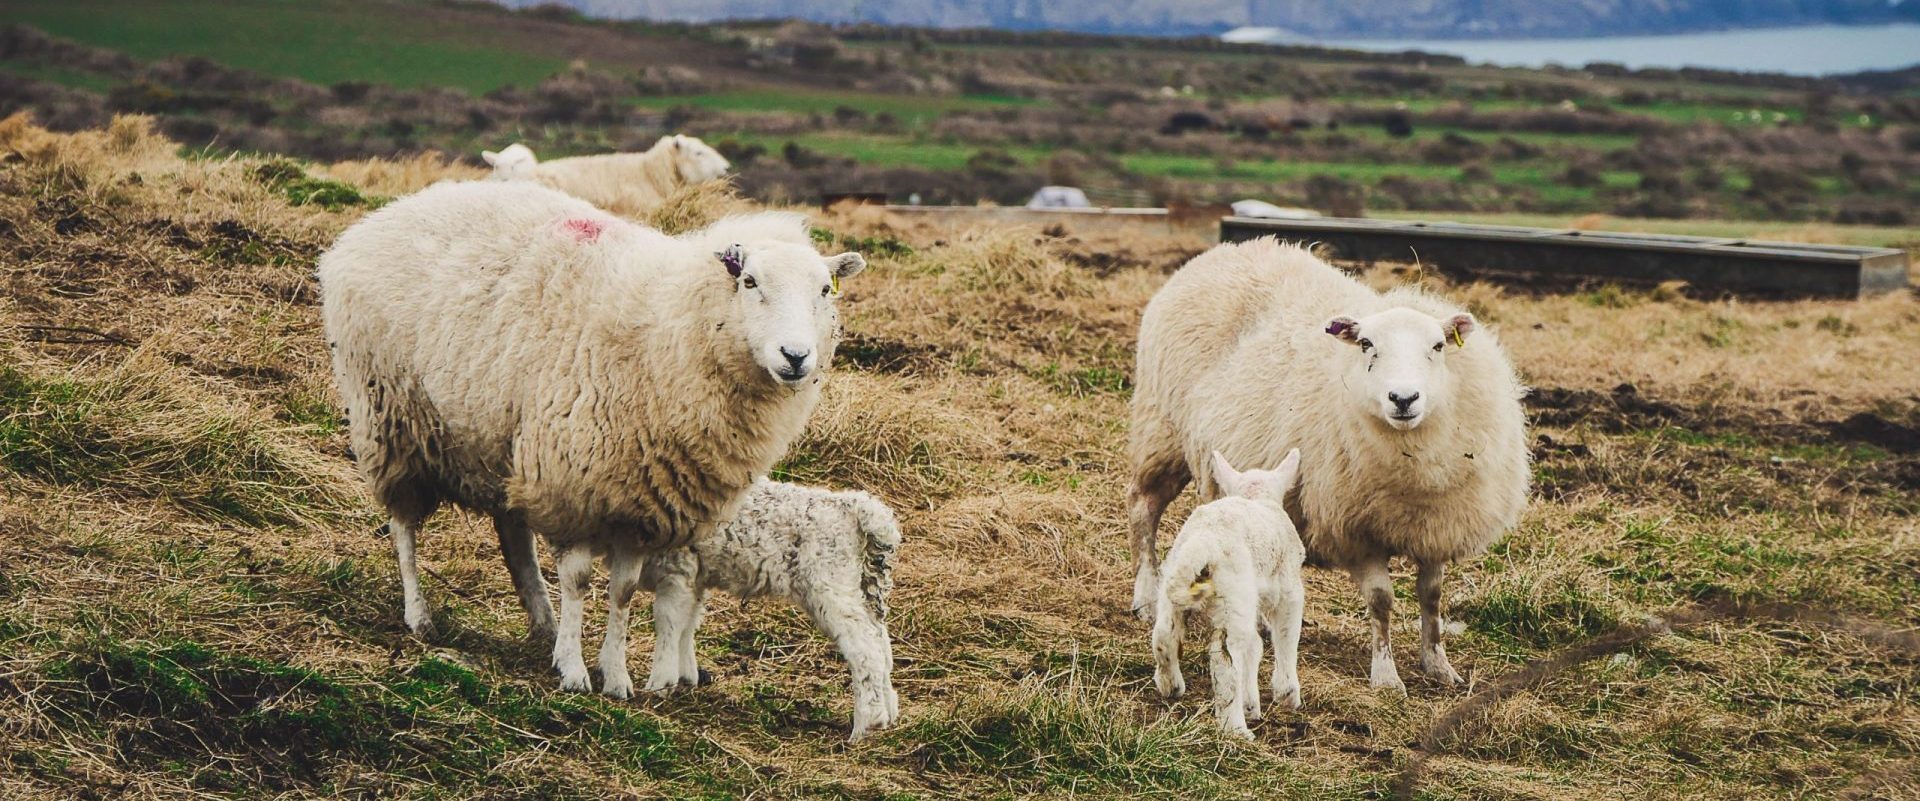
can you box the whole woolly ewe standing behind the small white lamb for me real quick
[1129,238,1528,692]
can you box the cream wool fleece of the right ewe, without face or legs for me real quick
[1129,238,1528,567]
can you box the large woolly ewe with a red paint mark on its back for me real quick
[319,182,866,697]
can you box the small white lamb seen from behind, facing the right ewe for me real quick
[1154,449,1306,740]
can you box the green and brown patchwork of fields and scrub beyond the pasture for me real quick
[0,0,1920,230]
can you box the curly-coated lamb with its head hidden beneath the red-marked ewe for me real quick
[629,478,900,740]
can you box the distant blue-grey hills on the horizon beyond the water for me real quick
[501,0,1920,38]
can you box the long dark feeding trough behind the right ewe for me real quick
[1219,217,1907,298]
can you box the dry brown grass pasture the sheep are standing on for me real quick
[0,121,1920,799]
